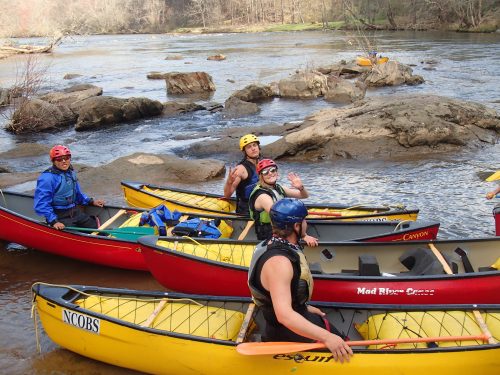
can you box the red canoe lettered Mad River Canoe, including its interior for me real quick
[139,236,500,304]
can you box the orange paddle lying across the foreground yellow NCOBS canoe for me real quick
[236,335,488,355]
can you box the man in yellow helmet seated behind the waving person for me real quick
[224,134,260,216]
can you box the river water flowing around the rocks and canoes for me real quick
[0,32,500,374]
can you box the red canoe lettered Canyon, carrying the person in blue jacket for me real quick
[0,192,439,271]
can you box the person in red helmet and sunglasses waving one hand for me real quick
[248,159,318,246]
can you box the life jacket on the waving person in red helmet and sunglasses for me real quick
[248,184,286,240]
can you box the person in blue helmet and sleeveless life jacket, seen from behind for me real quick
[248,198,353,362]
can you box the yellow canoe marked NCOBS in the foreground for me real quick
[32,283,500,375]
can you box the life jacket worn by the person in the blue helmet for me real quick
[248,238,313,314]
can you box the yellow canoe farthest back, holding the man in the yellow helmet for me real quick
[121,181,418,221]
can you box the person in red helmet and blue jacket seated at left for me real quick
[34,145,104,230]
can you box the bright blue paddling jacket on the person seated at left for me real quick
[33,167,92,225]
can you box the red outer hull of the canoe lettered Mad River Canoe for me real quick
[139,236,500,304]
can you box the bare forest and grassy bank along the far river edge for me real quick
[0,0,500,38]
